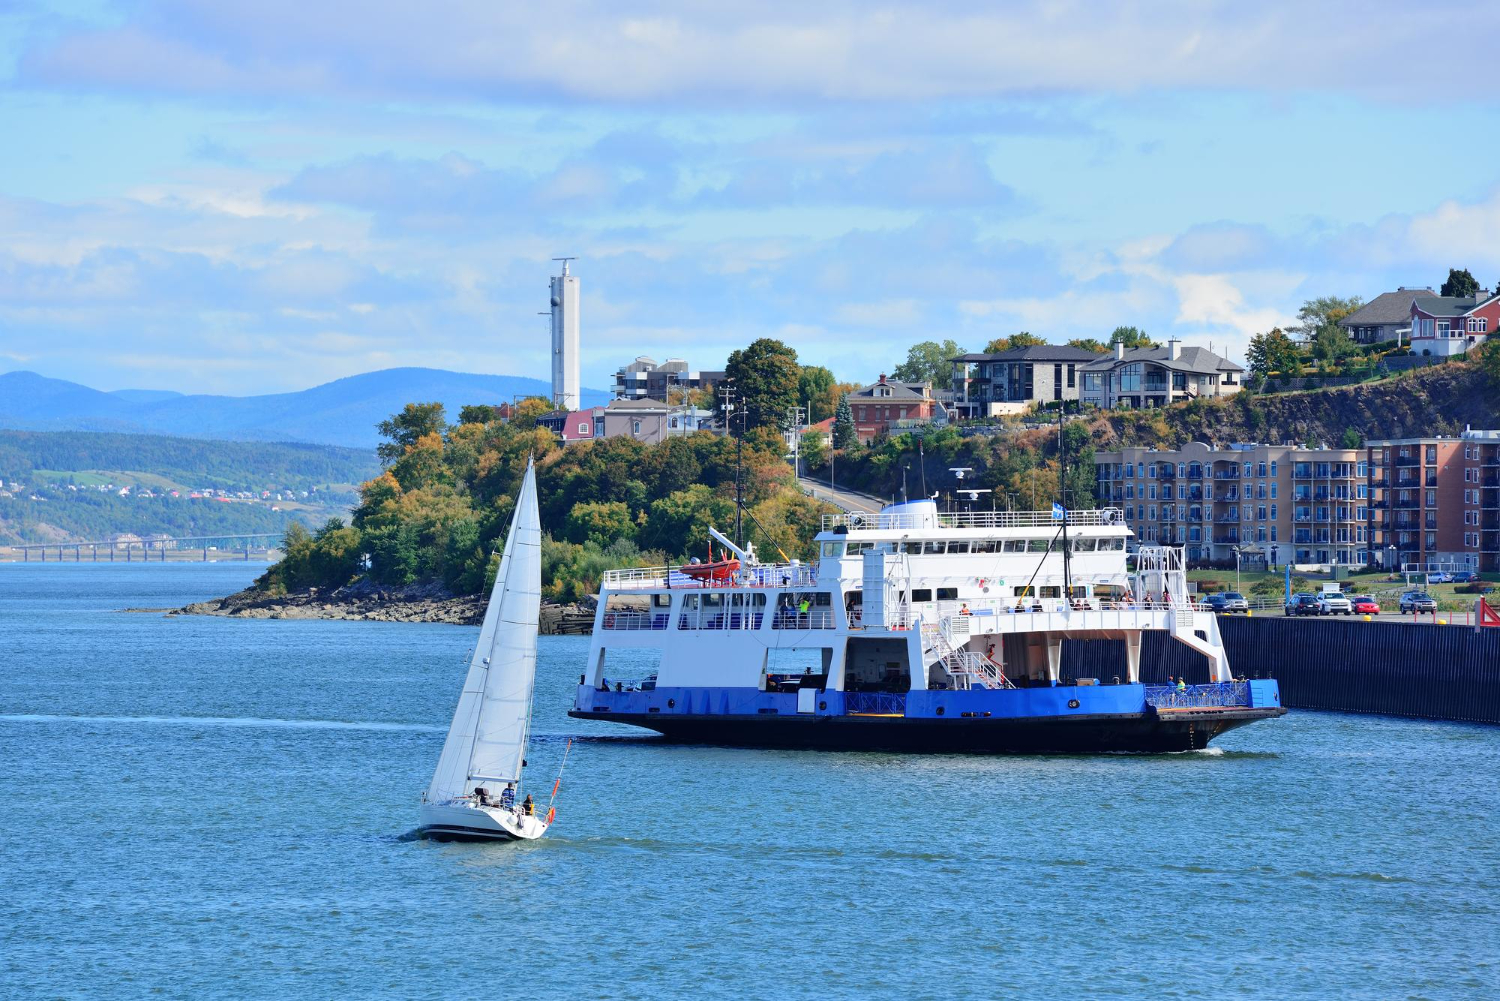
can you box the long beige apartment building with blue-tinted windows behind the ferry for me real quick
[1094,441,1370,566]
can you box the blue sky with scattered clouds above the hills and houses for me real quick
[0,0,1500,395]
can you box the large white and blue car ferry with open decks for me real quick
[570,500,1286,753]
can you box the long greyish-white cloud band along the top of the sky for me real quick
[21,0,1500,104]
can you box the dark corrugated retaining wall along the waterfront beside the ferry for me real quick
[1062,615,1500,723]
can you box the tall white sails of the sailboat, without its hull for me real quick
[428,464,542,803]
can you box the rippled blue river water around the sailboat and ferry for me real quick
[0,563,1500,998]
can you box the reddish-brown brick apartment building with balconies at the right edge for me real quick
[1367,431,1500,569]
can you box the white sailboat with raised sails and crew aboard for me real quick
[422,461,555,840]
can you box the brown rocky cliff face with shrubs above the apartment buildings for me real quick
[1092,365,1500,449]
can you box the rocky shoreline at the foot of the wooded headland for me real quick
[168,581,594,635]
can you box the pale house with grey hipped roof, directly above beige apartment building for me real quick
[1080,341,1245,408]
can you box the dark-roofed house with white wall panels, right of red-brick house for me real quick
[950,344,1104,417]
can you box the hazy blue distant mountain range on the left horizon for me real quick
[0,368,609,447]
